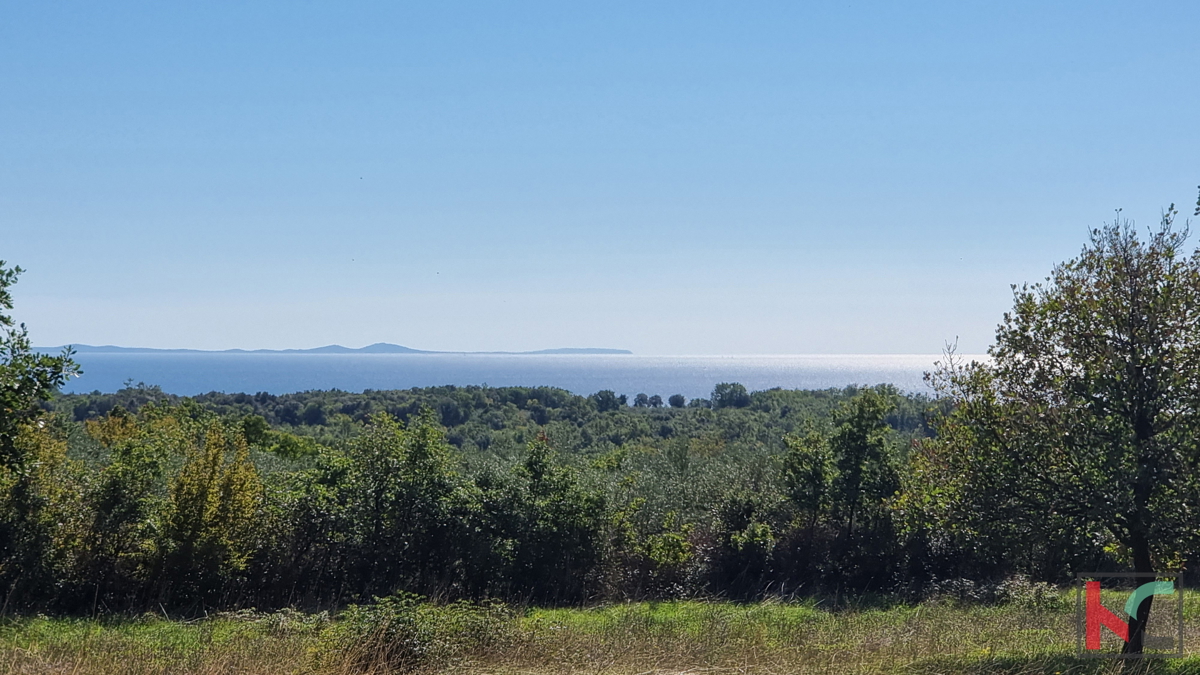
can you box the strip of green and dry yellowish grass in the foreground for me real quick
[0,596,1200,675]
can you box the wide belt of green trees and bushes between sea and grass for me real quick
[0,383,1106,613]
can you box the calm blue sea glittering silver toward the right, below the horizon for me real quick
[56,353,974,399]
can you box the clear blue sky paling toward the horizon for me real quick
[0,0,1200,354]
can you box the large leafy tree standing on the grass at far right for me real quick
[914,205,1200,652]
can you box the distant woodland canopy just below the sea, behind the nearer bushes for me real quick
[51,383,931,460]
